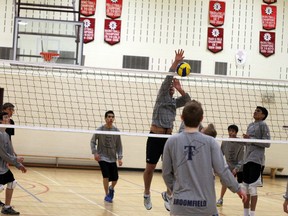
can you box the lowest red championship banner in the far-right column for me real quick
[259,31,275,57]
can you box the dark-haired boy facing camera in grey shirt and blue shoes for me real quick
[90,110,123,203]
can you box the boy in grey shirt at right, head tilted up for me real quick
[243,106,270,216]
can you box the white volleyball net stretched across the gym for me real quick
[0,61,288,142]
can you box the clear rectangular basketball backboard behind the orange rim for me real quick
[13,18,83,65]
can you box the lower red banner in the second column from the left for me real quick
[104,19,121,45]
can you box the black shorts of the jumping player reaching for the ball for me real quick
[146,132,168,164]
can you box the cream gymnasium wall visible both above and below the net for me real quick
[0,0,288,175]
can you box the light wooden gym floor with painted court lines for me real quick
[0,167,287,216]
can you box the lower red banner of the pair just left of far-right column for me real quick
[207,27,224,53]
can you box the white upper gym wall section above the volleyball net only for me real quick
[0,0,288,79]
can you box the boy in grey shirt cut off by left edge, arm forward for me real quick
[0,112,26,215]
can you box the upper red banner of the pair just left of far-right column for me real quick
[209,1,225,26]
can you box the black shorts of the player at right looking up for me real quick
[243,162,262,184]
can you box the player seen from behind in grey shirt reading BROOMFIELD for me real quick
[162,101,247,216]
